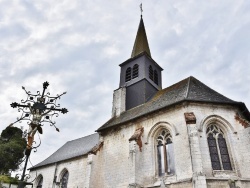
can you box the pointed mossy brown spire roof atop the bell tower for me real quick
[131,15,151,58]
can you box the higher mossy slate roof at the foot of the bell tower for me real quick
[97,76,250,132]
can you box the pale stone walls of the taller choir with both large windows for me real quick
[90,103,250,188]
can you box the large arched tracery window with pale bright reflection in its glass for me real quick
[156,129,175,176]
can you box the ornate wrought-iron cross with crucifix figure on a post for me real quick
[9,82,68,188]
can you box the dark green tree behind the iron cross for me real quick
[0,127,26,174]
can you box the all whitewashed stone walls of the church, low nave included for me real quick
[28,103,250,188]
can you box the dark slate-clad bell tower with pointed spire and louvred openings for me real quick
[112,16,163,116]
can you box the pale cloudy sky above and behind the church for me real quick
[0,0,250,174]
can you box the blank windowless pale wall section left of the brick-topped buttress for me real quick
[90,127,134,188]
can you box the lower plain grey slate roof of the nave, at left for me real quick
[30,133,99,169]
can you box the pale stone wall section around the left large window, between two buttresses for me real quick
[135,107,192,186]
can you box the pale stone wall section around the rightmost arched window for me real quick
[186,104,250,188]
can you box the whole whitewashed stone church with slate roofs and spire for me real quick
[30,18,250,188]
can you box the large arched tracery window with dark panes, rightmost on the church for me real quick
[206,124,232,170]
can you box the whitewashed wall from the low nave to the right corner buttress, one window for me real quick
[90,106,192,188]
